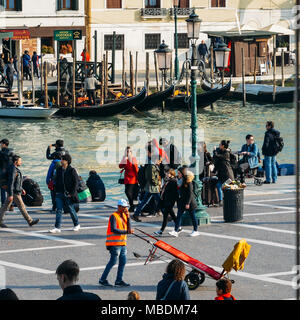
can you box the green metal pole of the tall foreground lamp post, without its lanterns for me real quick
[182,43,210,225]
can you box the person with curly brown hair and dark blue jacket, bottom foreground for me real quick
[156,259,190,300]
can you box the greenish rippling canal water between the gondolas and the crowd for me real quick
[0,100,295,204]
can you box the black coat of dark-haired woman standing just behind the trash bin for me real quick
[213,148,234,183]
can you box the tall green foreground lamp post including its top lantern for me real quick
[182,11,210,225]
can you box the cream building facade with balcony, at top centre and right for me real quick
[87,0,293,70]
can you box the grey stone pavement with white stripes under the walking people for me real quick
[0,176,296,300]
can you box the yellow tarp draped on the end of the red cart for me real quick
[222,239,251,273]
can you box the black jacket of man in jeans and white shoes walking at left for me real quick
[54,166,79,203]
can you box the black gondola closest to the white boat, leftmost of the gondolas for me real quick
[55,88,146,117]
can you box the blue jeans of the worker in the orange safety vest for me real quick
[100,246,127,282]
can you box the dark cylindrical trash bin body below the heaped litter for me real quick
[223,189,244,222]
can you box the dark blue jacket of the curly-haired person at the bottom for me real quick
[156,273,190,300]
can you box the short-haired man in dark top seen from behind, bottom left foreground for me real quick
[56,260,101,301]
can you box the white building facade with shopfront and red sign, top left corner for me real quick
[0,0,86,59]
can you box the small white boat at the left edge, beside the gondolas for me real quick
[0,106,58,119]
